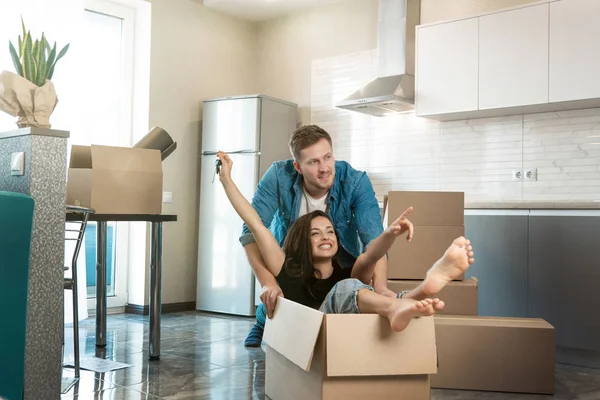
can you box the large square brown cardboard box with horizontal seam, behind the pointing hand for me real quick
[383,191,465,281]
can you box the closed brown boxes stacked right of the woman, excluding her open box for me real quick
[384,192,554,394]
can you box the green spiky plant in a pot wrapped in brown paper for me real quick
[0,19,69,128]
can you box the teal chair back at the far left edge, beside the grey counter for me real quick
[0,191,34,399]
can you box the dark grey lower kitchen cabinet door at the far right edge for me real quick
[528,210,600,367]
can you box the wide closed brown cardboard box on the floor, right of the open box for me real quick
[431,315,555,394]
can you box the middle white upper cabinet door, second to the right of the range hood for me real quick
[416,18,479,115]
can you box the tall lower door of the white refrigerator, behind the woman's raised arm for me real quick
[196,154,259,316]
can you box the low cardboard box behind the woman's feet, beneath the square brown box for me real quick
[388,279,478,316]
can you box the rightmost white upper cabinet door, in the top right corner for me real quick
[550,0,600,102]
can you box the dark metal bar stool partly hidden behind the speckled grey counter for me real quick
[64,205,94,379]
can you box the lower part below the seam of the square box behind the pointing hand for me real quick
[388,225,465,281]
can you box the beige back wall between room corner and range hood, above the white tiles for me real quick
[257,0,377,123]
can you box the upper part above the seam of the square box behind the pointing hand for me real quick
[387,191,465,226]
